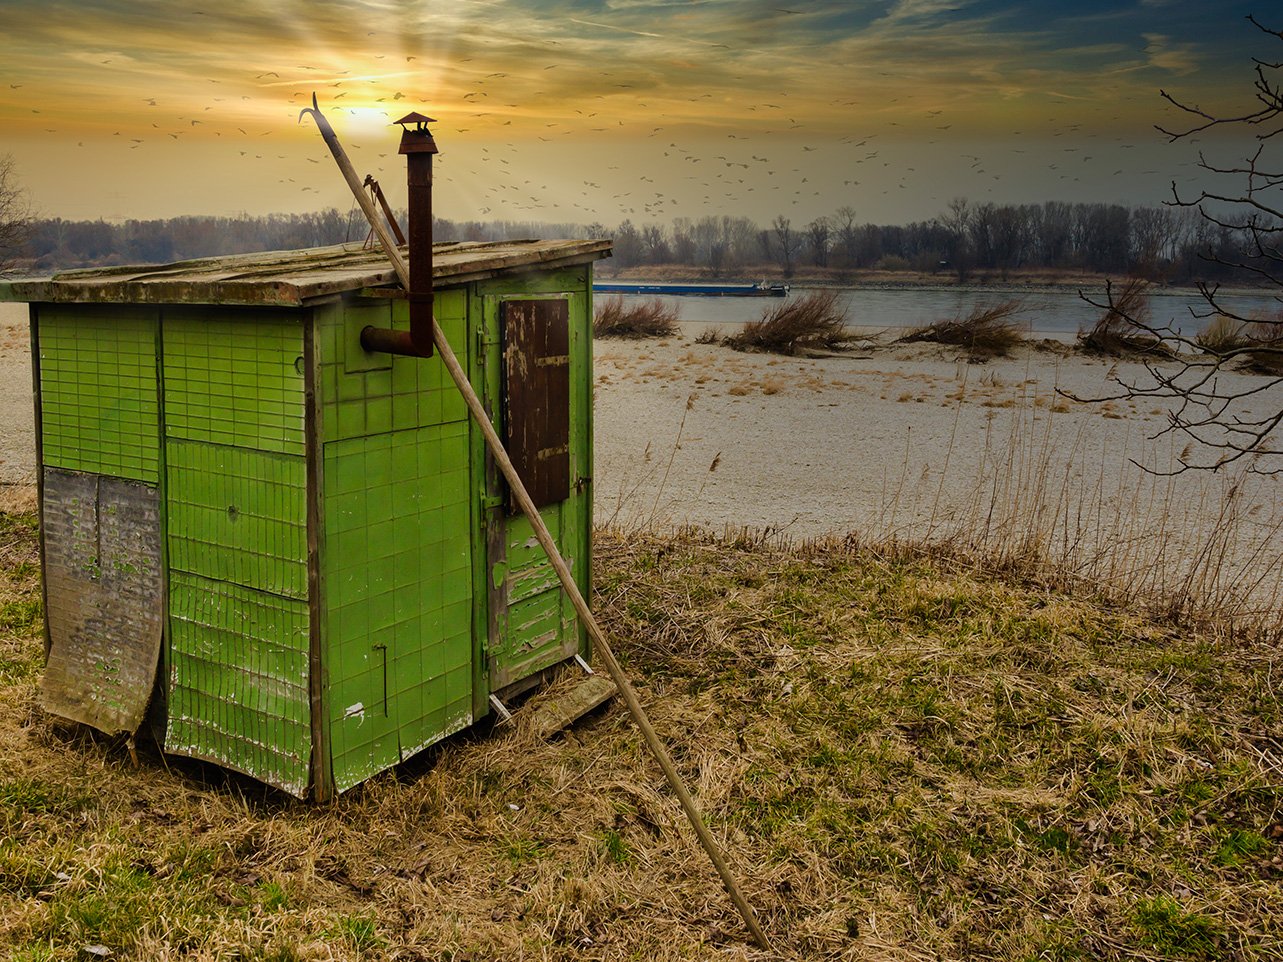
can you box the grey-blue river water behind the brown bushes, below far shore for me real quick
[598,287,1280,340]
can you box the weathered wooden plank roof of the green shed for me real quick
[0,240,611,307]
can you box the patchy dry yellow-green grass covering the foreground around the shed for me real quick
[0,497,1283,962]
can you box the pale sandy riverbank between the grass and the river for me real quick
[0,305,1283,625]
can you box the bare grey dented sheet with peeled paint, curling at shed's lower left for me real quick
[41,468,163,734]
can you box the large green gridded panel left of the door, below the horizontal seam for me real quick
[321,422,472,791]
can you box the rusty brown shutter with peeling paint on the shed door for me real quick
[503,298,570,508]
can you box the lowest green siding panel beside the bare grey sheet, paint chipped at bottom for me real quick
[166,572,312,797]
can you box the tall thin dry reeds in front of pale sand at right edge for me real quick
[871,371,1283,637]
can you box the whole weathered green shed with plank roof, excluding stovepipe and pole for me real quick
[0,240,609,800]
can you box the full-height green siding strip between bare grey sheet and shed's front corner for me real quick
[162,308,312,795]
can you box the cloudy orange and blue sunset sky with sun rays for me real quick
[0,0,1267,227]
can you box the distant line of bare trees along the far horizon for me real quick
[10,198,1267,282]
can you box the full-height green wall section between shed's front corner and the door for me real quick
[318,289,475,791]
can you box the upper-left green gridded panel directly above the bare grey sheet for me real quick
[38,305,160,485]
